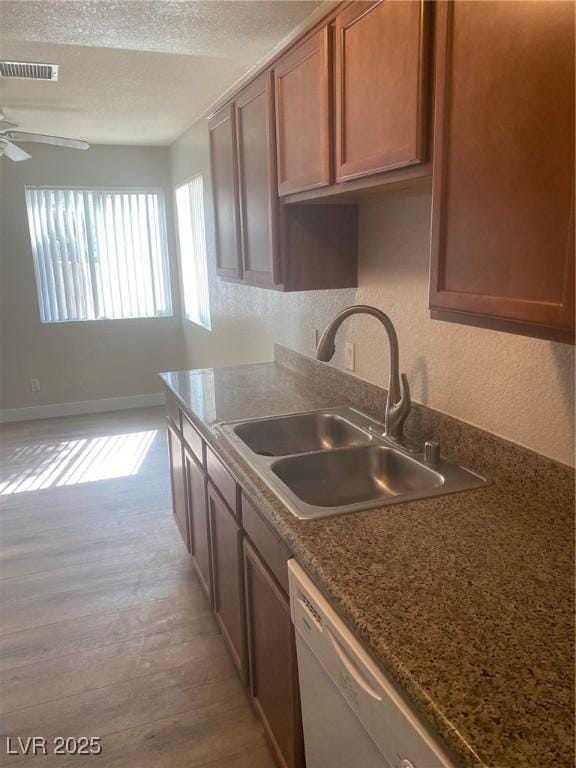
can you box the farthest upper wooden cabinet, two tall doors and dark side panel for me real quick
[210,80,358,291]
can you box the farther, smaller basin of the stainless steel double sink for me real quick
[234,412,372,456]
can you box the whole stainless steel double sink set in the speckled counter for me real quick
[222,407,488,519]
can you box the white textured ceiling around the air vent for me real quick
[0,0,320,144]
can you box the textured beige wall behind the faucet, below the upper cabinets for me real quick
[171,121,574,464]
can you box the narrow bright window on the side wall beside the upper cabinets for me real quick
[176,176,212,330]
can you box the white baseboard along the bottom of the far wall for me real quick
[0,392,164,424]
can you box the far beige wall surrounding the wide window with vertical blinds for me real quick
[0,145,185,409]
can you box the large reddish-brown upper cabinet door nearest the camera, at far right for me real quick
[430,0,574,341]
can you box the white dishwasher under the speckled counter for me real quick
[288,560,452,768]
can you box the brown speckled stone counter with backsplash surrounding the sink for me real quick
[162,348,574,768]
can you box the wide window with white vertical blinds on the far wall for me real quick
[26,187,172,323]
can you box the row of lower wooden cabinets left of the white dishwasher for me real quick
[166,394,305,768]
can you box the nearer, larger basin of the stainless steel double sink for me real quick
[271,445,444,507]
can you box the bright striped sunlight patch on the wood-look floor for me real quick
[0,429,158,495]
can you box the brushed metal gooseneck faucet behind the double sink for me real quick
[316,304,411,443]
